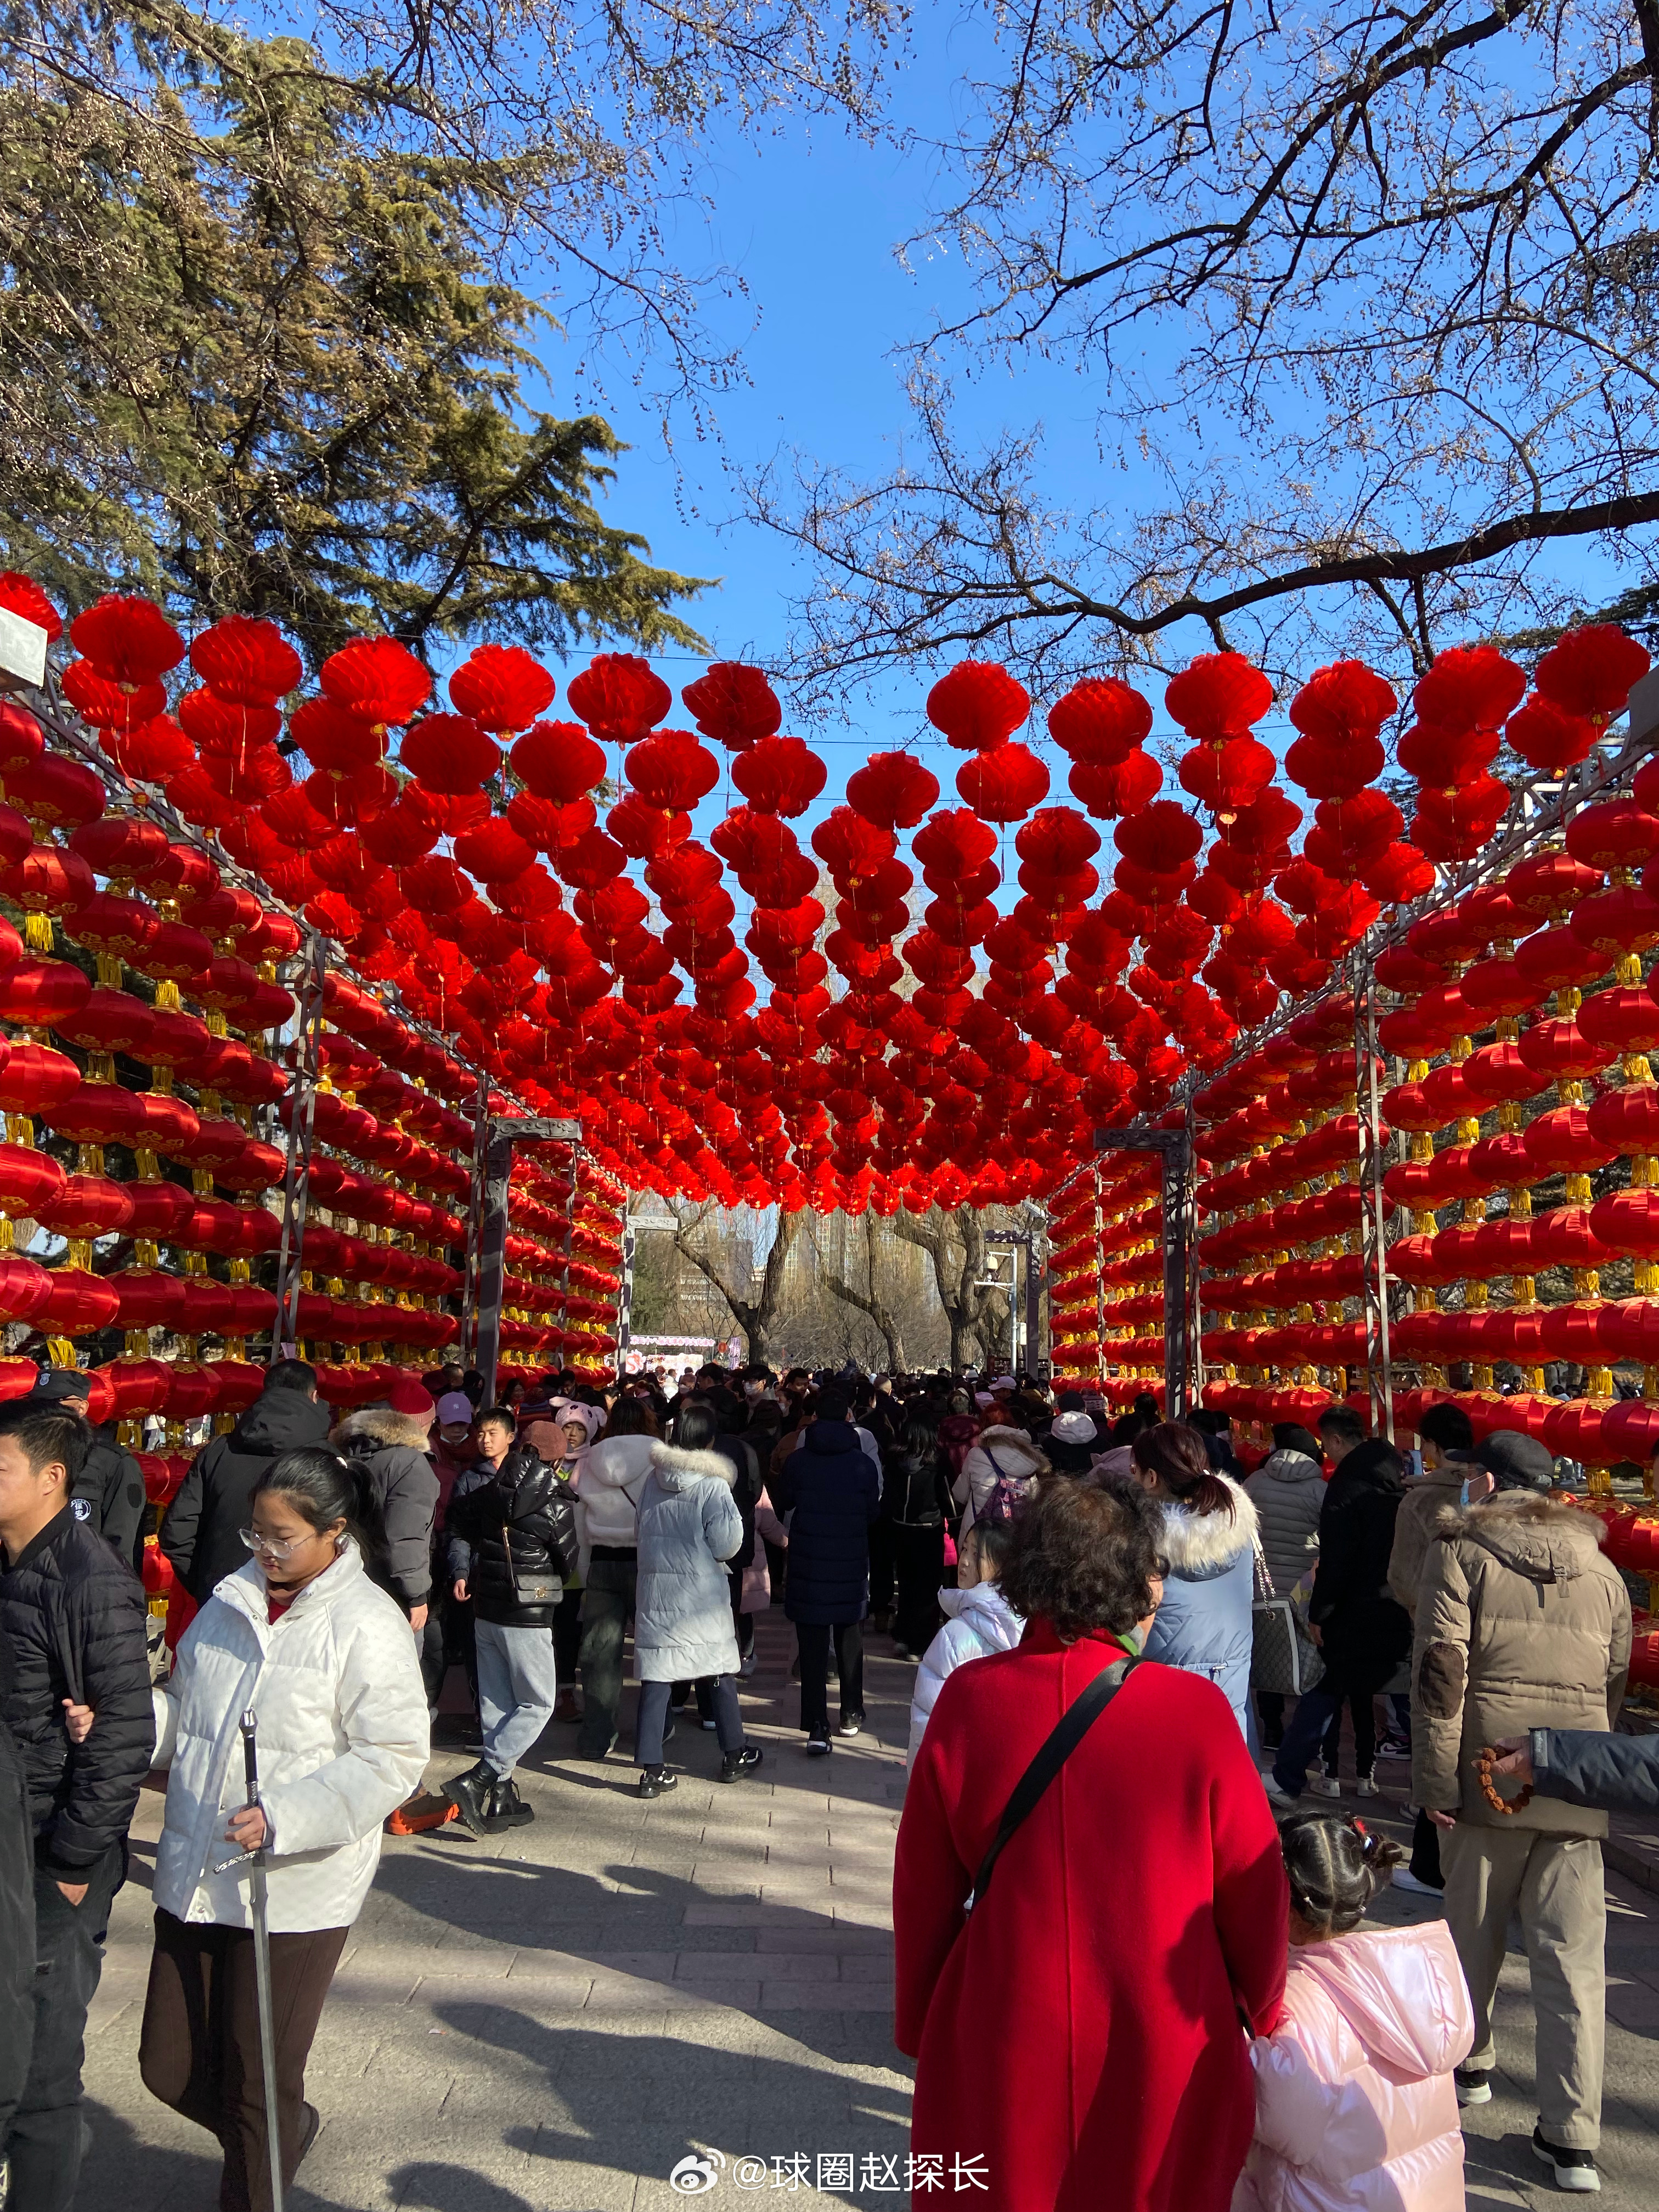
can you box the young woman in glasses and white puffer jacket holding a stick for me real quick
[139,1447,429,2212]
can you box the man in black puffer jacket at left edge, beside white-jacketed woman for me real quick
[0,1398,155,2212]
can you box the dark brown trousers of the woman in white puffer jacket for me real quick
[139,1911,349,2212]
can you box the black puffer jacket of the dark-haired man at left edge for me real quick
[0,1506,155,1876]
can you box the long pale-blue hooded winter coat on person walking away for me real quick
[633,1444,743,1681]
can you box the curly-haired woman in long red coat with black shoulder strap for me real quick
[894,1482,1288,2212]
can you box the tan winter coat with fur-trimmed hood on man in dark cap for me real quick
[1411,1491,1630,1836]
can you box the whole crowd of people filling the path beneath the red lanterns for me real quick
[0,1361,1659,2212]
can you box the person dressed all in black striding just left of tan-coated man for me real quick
[1267,1438,1411,1805]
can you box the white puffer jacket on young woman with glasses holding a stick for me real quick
[155,1544,429,1936]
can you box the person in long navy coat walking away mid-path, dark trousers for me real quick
[770,1385,881,1758]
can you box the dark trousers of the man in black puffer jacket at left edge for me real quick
[4,1843,126,2212]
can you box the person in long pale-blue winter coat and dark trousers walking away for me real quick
[633,1398,761,1798]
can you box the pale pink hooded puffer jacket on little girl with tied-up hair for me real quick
[1232,1920,1475,2212]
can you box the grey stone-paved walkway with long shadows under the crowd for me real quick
[84,1612,1659,2212]
